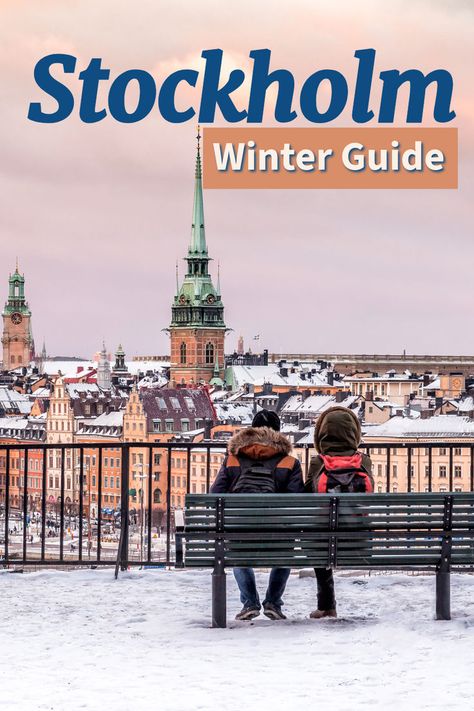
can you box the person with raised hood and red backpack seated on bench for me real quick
[305,406,374,619]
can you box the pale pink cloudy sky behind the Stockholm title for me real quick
[0,0,474,357]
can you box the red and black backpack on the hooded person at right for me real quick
[318,452,372,494]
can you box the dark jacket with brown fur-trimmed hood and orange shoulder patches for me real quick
[211,427,304,494]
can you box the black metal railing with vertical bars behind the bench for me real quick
[0,441,474,568]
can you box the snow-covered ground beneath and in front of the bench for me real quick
[0,570,474,711]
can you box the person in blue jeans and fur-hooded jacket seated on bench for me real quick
[211,410,304,620]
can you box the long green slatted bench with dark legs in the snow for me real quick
[176,493,474,627]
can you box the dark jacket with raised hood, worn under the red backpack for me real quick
[305,406,374,492]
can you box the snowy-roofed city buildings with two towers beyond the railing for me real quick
[0,137,474,525]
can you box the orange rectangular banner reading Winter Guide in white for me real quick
[203,126,458,190]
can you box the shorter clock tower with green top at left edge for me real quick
[2,264,35,370]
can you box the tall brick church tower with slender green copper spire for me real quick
[168,128,227,387]
